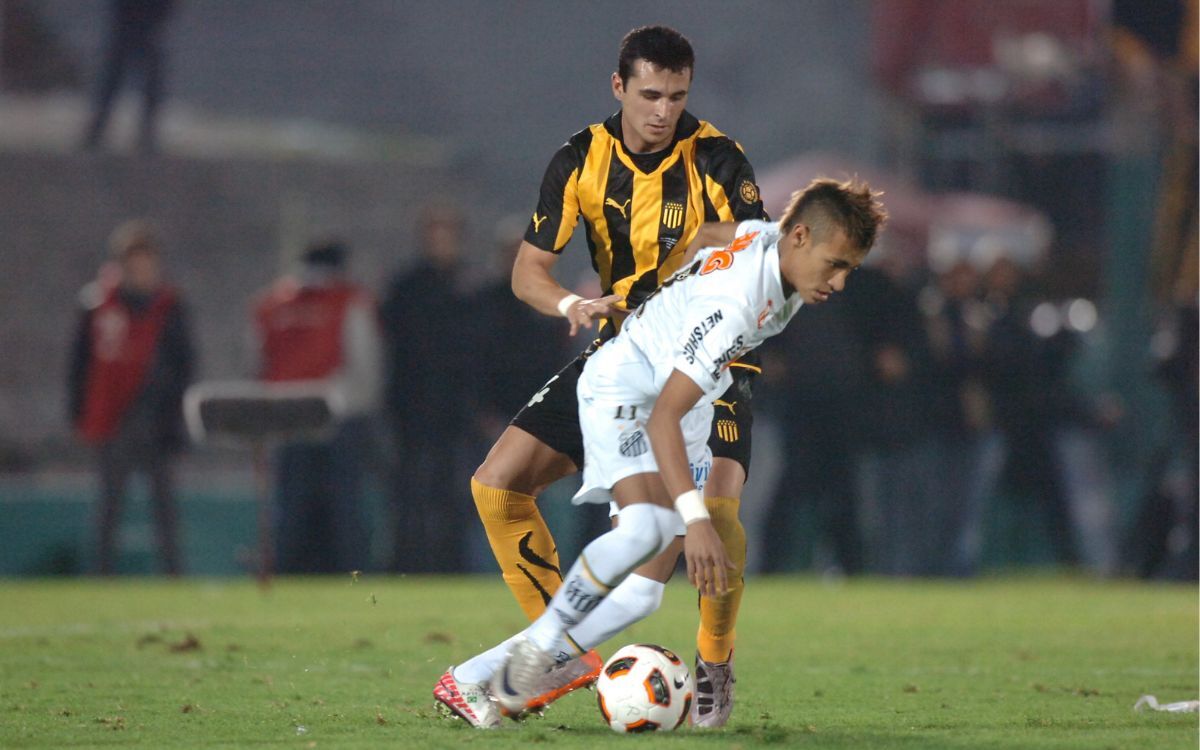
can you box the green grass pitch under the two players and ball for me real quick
[0,576,1200,750]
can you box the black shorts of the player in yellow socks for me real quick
[509,349,760,478]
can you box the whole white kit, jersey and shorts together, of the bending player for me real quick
[575,221,802,506]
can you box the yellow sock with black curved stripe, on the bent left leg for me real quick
[470,478,563,620]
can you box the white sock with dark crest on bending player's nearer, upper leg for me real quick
[526,503,679,658]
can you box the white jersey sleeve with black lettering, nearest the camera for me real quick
[673,296,750,391]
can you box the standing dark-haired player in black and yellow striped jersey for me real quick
[467,26,766,726]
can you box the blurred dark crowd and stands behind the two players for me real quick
[0,0,1198,578]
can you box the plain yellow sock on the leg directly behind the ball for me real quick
[696,497,746,661]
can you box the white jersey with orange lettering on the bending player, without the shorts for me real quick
[610,221,802,401]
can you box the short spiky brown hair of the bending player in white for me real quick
[779,178,888,251]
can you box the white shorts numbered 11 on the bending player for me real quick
[572,338,713,504]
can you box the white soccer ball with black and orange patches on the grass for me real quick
[596,643,692,732]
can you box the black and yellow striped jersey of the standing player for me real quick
[524,112,766,310]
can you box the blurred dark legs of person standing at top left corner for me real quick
[84,0,174,154]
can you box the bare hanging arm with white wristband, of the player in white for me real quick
[646,370,733,596]
